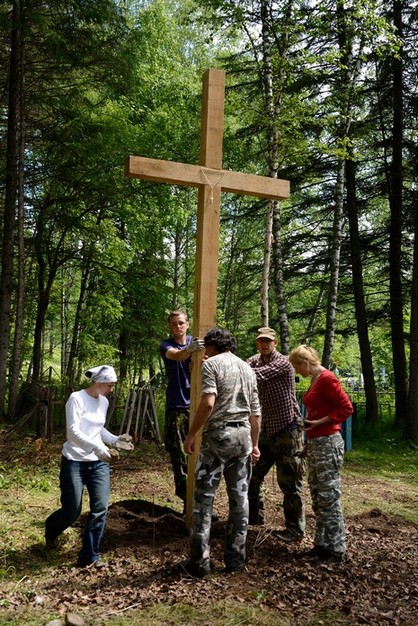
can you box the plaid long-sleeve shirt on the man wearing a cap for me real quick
[247,350,301,437]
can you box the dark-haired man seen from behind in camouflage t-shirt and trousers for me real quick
[183,328,260,577]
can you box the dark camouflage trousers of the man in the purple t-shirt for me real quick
[164,409,189,502]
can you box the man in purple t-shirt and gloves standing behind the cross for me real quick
[160,310,205,503]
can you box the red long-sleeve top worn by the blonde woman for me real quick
[303,370,353,439]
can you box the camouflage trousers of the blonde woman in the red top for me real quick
[308,433,346,554]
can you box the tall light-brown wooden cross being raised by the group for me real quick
[125,69,290,528]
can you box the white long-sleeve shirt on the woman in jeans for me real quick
[62,389,118,461]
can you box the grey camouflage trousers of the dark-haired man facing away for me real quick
[190,425,252,571]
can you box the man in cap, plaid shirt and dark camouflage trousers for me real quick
[247,328,305,542]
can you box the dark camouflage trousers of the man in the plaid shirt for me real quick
[248,428,305,536]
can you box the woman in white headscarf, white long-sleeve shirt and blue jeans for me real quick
[45,365,133,567]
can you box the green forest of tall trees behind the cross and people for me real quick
[0,0,418,442]
